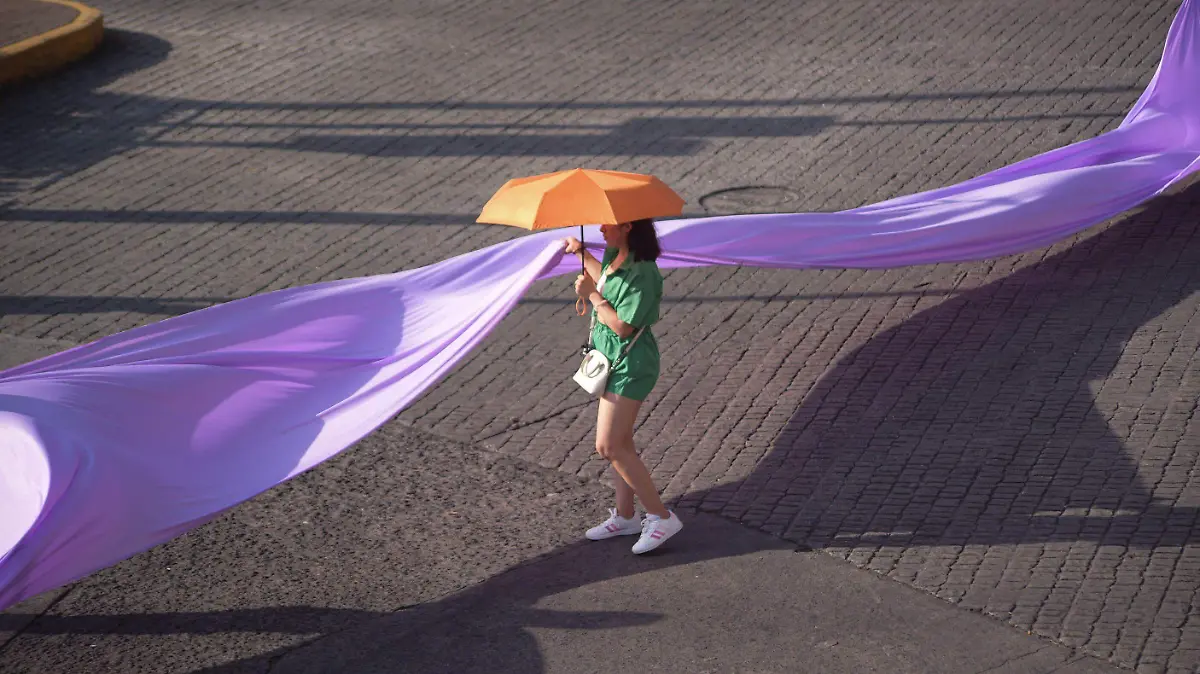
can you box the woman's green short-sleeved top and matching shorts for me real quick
[592,248,662,401]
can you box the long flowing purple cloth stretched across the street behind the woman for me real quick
[0,0,1200,608]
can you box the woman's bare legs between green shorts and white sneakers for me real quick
[596,393,671,519]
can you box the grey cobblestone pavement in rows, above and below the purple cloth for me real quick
[0,0,1200,672]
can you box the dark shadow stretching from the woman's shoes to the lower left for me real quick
[0,534,691,674]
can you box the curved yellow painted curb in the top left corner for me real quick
[0,0,104,84]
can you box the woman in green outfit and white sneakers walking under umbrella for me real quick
[565,219,683,554]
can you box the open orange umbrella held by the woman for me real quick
[475,169,684,315]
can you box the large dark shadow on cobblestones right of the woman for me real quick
[685,177,1200,556]
